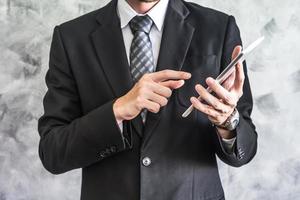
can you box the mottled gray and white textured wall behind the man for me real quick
[0,0,300,200]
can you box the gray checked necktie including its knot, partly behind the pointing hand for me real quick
[129,15,154,123]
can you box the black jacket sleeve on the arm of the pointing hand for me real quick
[38,27,128,174]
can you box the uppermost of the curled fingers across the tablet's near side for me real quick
[206,78,236,107]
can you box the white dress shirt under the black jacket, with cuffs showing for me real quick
[117,0,236,151]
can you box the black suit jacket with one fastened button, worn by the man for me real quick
[38,0,257,200]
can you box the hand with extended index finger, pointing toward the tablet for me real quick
[113,70,191,123]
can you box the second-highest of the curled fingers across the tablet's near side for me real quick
[195,84,231,113]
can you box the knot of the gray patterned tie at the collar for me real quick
[129,15,153,34]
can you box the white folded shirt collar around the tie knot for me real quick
[117,0,169,31]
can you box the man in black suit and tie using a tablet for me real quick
[38,0,257,200]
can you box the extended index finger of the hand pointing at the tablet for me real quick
[150,69,192,82]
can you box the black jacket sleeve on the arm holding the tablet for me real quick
[214,16,257,167]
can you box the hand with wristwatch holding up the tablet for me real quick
[191,46,245,138]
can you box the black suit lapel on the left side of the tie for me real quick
[91,0,143,136]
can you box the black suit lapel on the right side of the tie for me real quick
[143,0,194,146]
